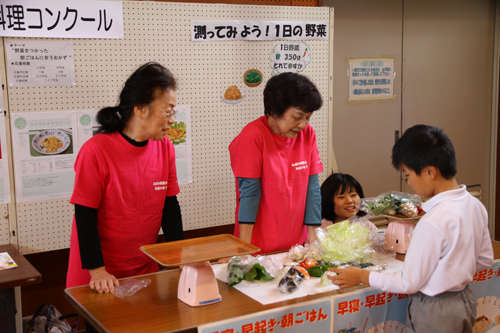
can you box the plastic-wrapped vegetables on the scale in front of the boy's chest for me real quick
[361,191,422,217]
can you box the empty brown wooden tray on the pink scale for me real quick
[140,234,260,267]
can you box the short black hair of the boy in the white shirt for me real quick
[392,125,457,179]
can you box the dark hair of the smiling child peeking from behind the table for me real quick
[321,173,366,221]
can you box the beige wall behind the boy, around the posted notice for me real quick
[323,0,495,213]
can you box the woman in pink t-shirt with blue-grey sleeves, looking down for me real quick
[229,73,323,253]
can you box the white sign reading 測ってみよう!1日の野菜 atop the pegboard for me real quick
[191,20,328,42]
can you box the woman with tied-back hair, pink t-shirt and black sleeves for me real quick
[66,63,183,304]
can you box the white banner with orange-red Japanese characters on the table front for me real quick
[198,300,332,333]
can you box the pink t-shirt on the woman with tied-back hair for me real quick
[66,132,179,287]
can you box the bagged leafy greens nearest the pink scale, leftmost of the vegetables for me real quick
[227,255,280,287]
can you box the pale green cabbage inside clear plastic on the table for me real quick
[317,220,373,262]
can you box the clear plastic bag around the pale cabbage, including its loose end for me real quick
[316,216,395,265]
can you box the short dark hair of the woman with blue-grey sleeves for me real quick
[264,72,323,118]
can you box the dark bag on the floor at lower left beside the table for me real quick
[23,304,80,333]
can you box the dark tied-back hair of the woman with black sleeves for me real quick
[96,62,177,133]
